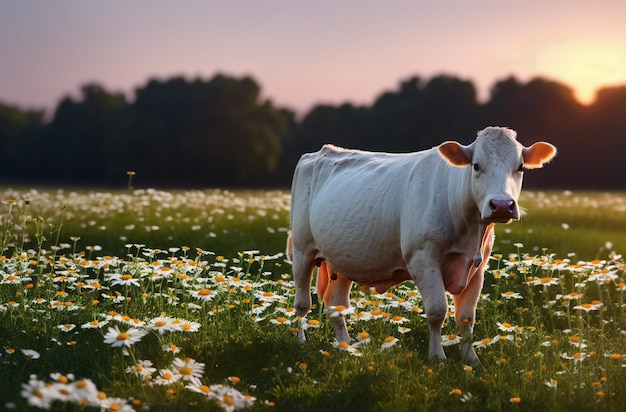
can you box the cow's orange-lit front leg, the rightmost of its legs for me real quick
[454,272,484,365]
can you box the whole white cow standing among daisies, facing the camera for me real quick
[288,127,556,363]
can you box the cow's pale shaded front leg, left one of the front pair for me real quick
[409,255,448,361]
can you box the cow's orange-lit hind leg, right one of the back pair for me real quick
[318,261,352,343]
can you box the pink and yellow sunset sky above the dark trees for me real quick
[0,0,626,113]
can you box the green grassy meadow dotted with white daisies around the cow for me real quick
[0,188,626,411]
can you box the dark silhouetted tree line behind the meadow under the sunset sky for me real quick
[0,74,626,189]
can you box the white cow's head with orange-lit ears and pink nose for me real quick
[439,127,556,223]
